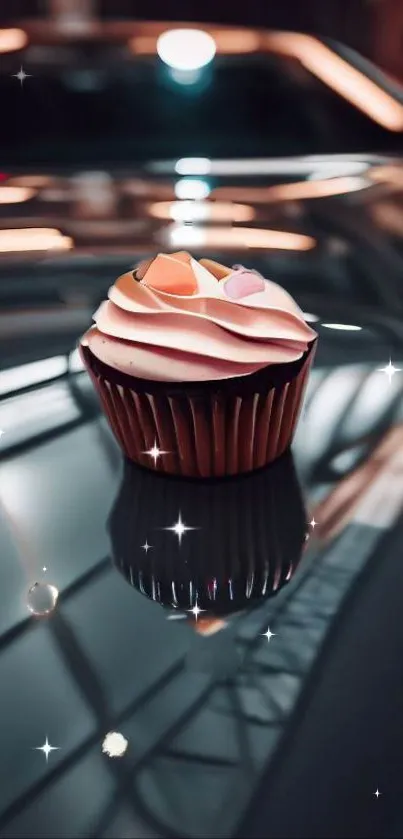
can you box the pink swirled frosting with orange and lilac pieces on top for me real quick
[82,249,316,382]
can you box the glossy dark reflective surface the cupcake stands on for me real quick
[0,19,403,839]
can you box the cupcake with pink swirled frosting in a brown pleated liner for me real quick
[80,252,317,478]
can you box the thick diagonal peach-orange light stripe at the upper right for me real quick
[266,32,403,131]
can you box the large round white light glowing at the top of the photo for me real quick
[157,29,216,70]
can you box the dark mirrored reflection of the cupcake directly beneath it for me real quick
[109,453,307,629]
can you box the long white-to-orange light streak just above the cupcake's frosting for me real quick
[169,224,316,251]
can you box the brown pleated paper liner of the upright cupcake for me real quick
[81,342,316,478]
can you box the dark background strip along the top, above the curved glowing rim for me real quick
[0,0,403,78]
